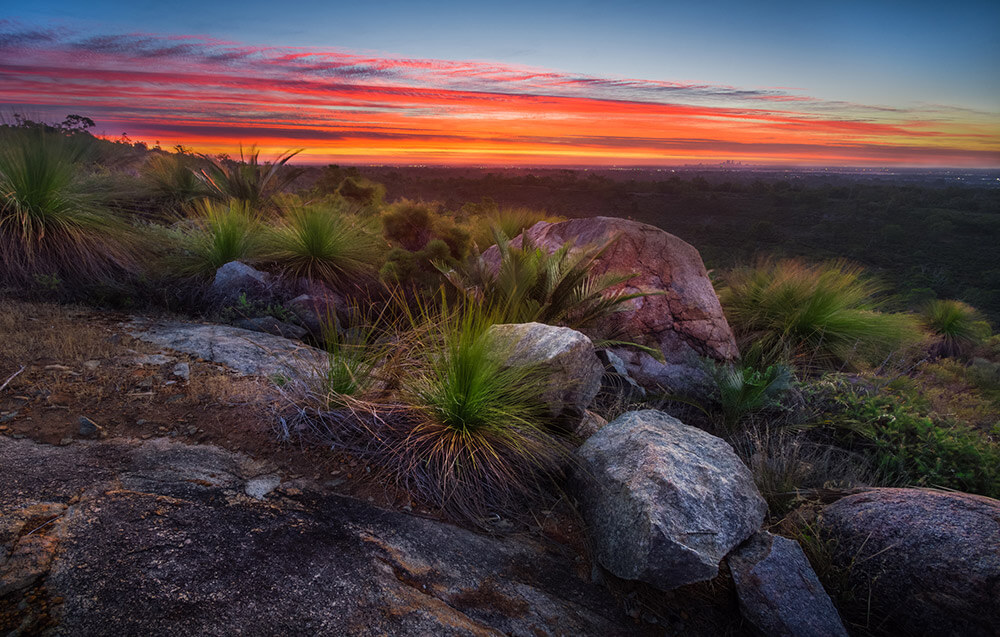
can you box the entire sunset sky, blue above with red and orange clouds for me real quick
[0,0,1000,168]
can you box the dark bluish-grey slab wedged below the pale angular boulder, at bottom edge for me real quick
[727,531,847,637]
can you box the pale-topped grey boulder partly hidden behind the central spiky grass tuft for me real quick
[489,323,604,420]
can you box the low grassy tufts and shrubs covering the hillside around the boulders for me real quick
[0,115,1000,528]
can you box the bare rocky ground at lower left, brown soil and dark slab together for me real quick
[0,301,715,636]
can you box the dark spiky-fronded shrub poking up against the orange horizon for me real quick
[196,146,302,213]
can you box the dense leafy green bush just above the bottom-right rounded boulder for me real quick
[812,381,1000,497]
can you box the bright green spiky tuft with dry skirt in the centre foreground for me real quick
[397,305,568,524]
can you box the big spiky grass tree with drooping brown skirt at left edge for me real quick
[0,130,137,285]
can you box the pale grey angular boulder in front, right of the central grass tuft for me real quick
[576,410,767,590]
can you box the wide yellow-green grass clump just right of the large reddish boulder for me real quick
[719,260,918,369]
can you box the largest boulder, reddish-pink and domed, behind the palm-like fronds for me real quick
[483,217,739,391]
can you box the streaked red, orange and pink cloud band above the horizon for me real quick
[0,21,1000,166]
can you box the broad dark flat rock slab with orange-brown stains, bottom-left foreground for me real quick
[0,438,636,637]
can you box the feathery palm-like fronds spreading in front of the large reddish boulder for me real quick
[442,233,644,327]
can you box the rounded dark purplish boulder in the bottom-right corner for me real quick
[819,489,1000,637]
